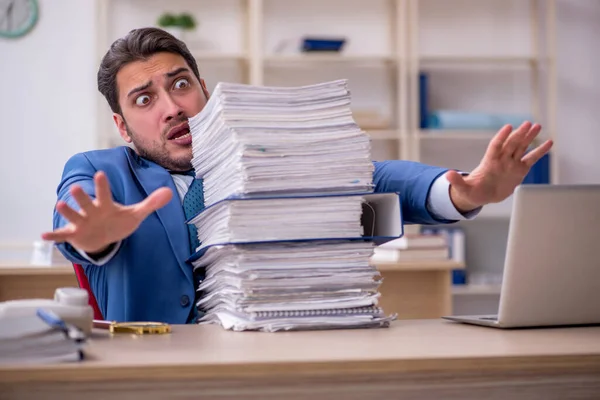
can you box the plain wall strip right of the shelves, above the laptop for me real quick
[557,0,600,183]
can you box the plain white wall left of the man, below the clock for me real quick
[0,0,96,244]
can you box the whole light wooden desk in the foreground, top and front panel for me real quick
[0,320,600,400]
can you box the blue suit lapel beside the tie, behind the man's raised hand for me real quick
[126,149,193,284]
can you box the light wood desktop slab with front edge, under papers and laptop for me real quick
[0,320,600,383]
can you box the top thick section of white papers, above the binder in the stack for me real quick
[189,80,373,205]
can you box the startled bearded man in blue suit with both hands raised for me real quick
[42,28,552,323]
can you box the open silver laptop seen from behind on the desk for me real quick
[443,185,600,328]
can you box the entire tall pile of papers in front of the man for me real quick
[188,80,400,331]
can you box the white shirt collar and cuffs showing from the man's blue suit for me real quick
[77,170,481,265]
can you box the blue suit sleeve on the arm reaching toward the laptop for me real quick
[373,160,455,225]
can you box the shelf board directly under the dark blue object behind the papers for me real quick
[264,53,396,65]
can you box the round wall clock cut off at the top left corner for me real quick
[0,0,39,38]
